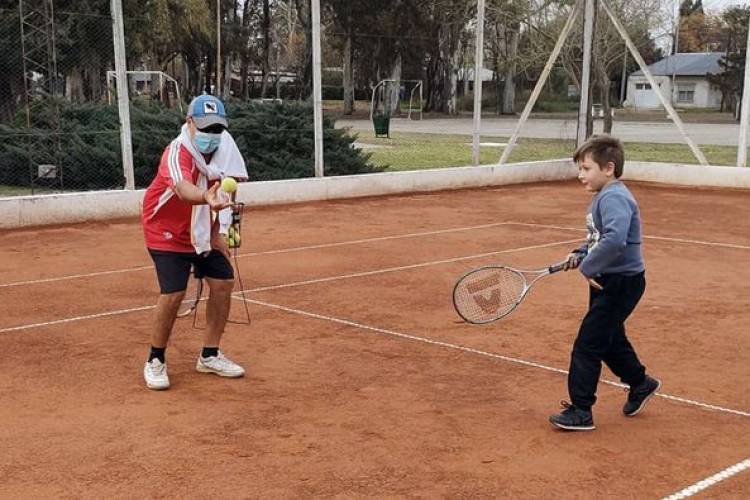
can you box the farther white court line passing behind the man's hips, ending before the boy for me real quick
[0,222,514,288]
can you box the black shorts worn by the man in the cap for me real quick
[148,248,234,293]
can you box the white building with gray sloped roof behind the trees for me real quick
[624,52,724,109]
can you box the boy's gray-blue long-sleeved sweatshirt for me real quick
[578,181,645,278]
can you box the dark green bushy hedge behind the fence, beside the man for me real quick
[0,101,379,190]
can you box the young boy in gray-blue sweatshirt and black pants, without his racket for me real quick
[549,136,661,431]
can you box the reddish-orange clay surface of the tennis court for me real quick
[0,182,750,498]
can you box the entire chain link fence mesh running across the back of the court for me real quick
[0,0,748,196]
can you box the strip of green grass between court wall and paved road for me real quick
[357,131,750,171]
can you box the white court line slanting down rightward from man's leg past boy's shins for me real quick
[234,297,750,417]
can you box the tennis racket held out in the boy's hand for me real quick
[453,261,567,325]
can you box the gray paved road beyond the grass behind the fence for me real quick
[336,118,740,146]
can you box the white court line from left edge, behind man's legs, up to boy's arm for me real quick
[0,239,578,333]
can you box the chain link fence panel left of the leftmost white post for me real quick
[0,0,124,196]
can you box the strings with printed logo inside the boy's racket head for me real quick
[454,268,526,323]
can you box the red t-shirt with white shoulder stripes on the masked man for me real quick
[141,140,200,253]
